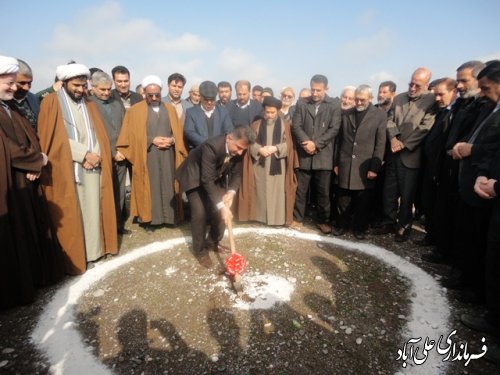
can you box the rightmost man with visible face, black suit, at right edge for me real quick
[452,62,500,302]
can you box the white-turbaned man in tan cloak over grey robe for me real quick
[115,75,187,232]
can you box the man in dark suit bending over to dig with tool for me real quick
[175,126,255,268]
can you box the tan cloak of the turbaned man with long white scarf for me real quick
[38,93,118,275]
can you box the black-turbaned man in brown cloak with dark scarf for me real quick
[238,96,297,225]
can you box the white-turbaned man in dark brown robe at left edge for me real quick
[0,56,63,308]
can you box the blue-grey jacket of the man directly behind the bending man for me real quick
[184,105,233,148]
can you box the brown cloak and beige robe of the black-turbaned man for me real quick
[238,119,298,225]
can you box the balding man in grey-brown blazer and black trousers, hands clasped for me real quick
[374,68,435,242]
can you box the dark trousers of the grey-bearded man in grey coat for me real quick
[337,188,375,232]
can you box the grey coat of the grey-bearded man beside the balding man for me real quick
[335,105,387,190]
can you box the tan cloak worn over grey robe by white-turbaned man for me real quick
[116,101,187,223]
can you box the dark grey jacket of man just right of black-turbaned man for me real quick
[292,96,341,170]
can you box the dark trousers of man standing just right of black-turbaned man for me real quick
[293,169,332,224]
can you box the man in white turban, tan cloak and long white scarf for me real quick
[38,64,118,274]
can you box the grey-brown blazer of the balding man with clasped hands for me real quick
[387,92,436,168]
